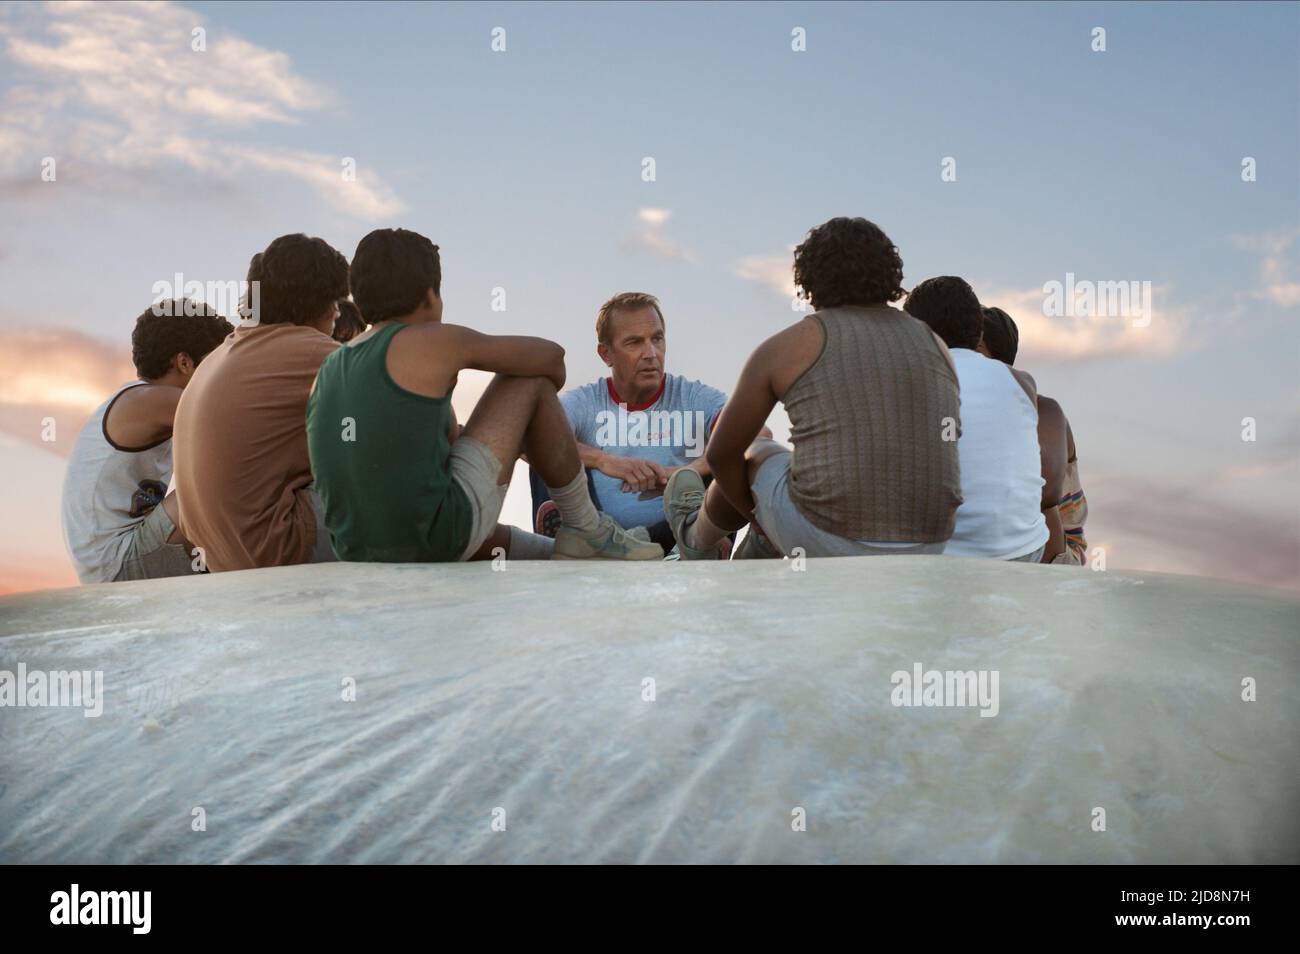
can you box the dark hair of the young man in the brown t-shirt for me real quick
[248,233,347,325]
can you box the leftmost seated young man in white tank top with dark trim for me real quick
[62,299,233,584]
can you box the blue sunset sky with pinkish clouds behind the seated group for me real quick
[0,3,1300,591]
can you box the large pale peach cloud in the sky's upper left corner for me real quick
[0,3,403,221]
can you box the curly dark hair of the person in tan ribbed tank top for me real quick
[794,216,902,308]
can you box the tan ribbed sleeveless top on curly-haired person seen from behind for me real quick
[783,305,962,543]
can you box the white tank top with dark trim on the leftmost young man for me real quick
[64,381,172,584]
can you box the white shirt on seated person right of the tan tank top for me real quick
[944,348,1049,560]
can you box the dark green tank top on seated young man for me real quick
[307,324,473,563]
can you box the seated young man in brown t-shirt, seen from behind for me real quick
[176,234,347,572]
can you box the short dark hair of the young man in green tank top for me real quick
[351,229,442,325]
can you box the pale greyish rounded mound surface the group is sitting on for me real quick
[0,558,1300,863]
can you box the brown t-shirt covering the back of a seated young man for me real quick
[174,324,338,572]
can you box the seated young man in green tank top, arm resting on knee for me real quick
[307,229,663,563]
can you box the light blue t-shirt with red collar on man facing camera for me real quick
[560,374,727,528]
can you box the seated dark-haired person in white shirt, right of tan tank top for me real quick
[906,276,1065,563]
